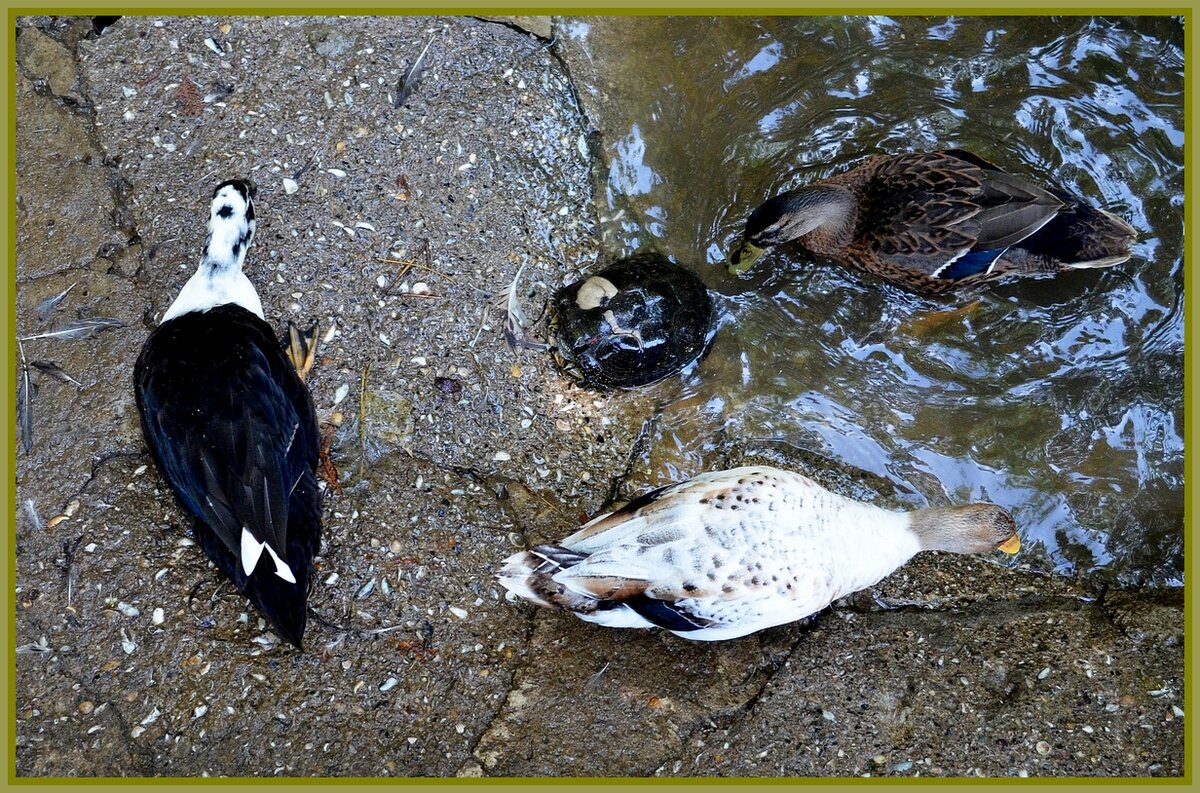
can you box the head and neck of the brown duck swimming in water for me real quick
[726,185,854,275]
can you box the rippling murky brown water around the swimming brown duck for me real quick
[563,17,1183,583]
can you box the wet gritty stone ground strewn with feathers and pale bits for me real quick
[14,17,1186,777]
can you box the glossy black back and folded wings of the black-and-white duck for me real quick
[134,305,319,587]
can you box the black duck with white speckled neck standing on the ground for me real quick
[134,180,320,647]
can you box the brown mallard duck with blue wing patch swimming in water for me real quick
[728,149,1138,294]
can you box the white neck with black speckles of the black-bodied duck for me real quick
[162,209,263,322]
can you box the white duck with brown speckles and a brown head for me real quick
[498,467,1020,641]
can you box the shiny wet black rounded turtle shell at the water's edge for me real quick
[550,253,713,389]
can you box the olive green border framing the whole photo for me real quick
[0,0,1200,791]
